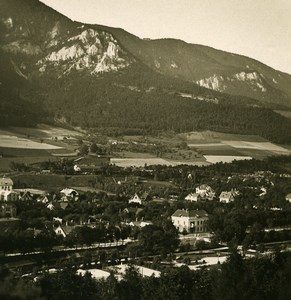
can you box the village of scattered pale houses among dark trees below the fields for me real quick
[0,152,291,277]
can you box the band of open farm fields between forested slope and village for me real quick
[0,124,291,172]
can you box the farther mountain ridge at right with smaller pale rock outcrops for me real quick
[96,26,291,107]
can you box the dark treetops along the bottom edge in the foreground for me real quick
[0,252,291,300]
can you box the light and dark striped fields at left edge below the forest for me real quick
[0,125,82,172]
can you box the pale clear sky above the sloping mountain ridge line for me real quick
[41,0,291,74]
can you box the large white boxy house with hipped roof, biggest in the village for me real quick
[171,209,208,233]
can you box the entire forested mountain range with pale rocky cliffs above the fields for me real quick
[0,0,291,143]
